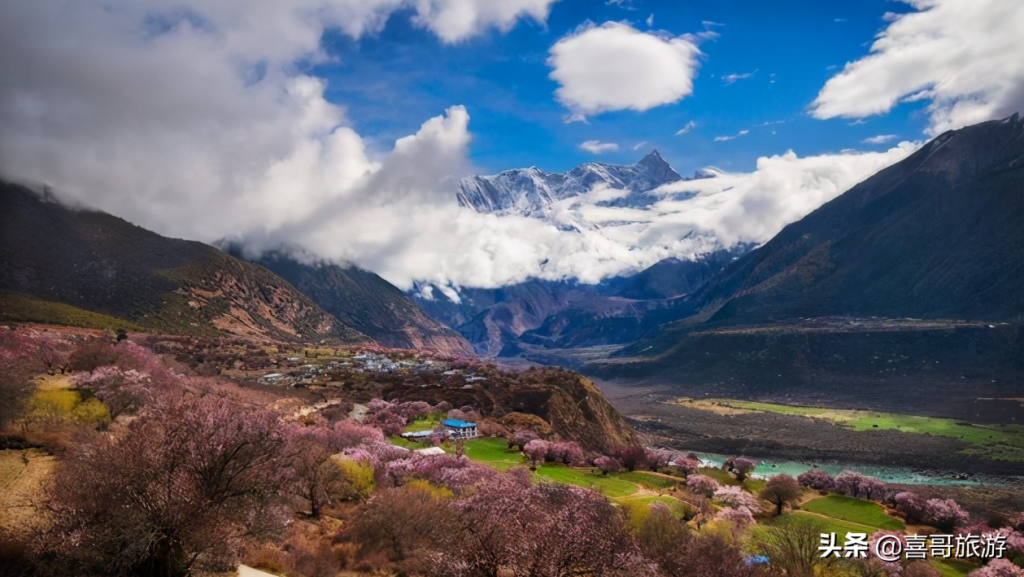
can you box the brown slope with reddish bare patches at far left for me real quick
[0,183,369,341]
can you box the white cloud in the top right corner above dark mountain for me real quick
[811,0,1024,134]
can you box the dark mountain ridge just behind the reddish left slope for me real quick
[229,250,473,356]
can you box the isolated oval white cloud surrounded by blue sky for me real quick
[548,23,700,115]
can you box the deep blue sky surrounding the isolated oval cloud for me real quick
[311,0,928,173]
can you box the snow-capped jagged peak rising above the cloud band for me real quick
[458,151,710,216]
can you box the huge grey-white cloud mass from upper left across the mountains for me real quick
[0,0,929,288]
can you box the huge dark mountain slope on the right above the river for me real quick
[586,115,1024,419]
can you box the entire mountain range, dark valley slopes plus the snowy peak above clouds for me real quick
[0,115,1024,420]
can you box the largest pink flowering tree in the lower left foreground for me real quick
[41,396,287,577]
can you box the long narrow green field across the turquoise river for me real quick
[701,399,1024,460]
